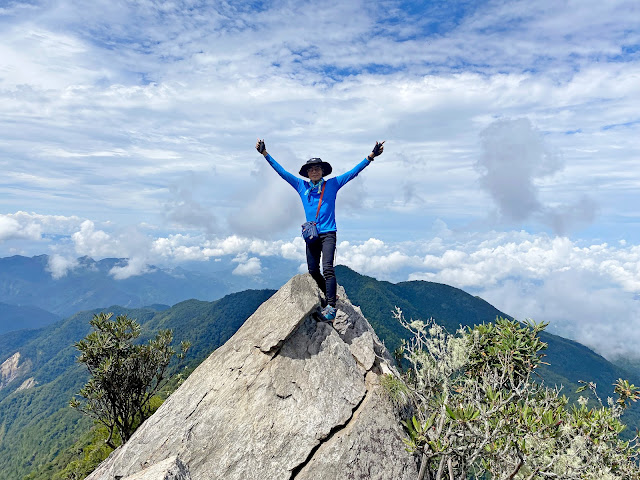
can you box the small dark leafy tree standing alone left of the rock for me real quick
[70,313,189,448]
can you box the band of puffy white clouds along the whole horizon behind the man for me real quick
[5,206,640,358]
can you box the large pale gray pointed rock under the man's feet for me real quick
[87,275,417,480]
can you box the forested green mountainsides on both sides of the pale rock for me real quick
[5,266,640,480]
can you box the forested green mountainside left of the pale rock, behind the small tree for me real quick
[0,290,274,480]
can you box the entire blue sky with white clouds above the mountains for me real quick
[0,0,640,358]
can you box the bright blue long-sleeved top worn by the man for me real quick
[265,154,370,233]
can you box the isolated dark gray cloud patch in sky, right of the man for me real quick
[476,118,595,235]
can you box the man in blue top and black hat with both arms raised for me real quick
[256,139,384,320]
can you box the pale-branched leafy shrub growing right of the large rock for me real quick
[394,309,640,480]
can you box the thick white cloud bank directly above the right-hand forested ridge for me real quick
[408,232,640,359]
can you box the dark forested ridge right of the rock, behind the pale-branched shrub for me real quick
[336,265,640,426]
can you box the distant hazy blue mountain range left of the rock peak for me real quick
[0,255,296,324]
